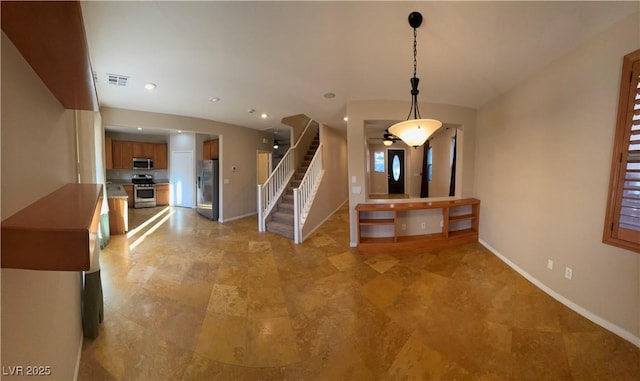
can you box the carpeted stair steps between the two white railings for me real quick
[266,132,320,239]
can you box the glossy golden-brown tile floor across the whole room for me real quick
[79,206,640,380]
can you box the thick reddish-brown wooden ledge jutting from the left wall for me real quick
[1,184,102,271]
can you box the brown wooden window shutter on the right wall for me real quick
[603,50,640,252]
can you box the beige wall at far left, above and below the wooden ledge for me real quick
[0,33,82,380]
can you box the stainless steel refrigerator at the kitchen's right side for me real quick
[196,160,220,220]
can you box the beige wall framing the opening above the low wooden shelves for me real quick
[347,101,476,246]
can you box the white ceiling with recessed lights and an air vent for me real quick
[82,1,640,130]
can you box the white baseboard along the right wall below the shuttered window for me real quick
[478,239,640,347]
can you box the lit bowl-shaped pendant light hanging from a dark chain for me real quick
[389,12,442,147]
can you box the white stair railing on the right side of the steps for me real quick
[293,143,324,243]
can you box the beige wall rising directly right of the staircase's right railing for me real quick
[302,125,349,239]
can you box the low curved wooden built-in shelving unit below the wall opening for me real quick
[356,198,480,252]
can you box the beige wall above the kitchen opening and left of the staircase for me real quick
[101,107,273,221]
